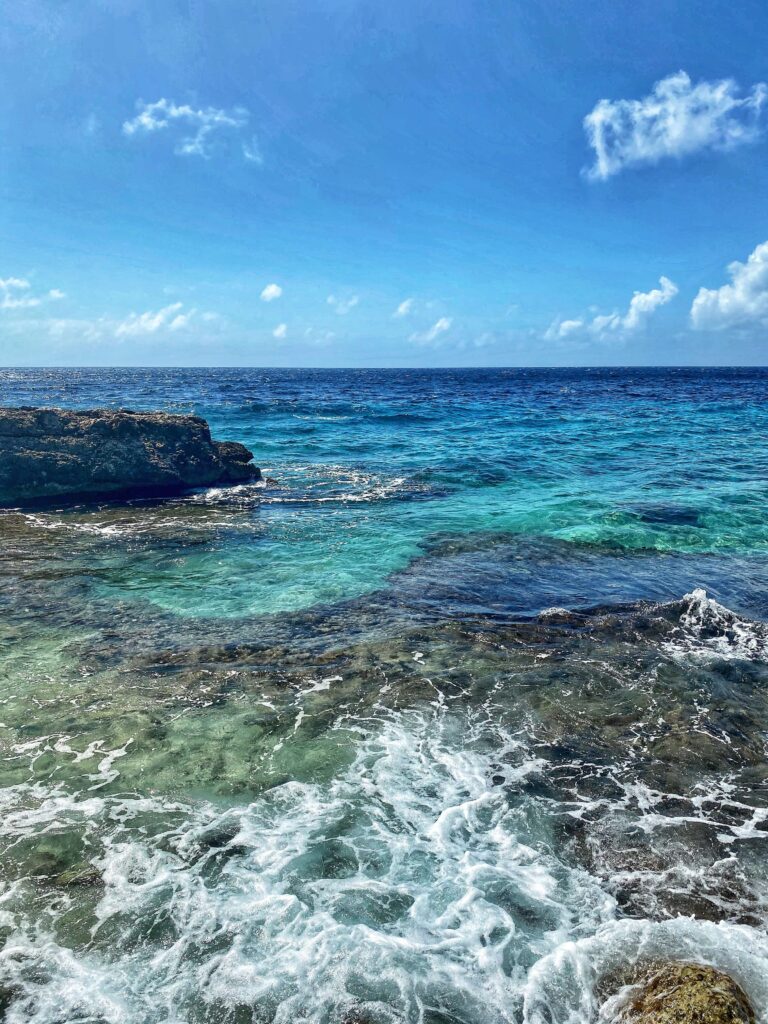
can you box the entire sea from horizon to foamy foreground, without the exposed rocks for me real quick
[0,369,768,1024]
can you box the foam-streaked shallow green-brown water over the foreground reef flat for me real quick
[2,581,768,1020]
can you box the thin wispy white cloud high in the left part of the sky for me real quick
[123,98,252,163]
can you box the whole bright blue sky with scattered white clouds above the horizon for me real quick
[0,0,768,367]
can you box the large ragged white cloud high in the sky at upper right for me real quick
[584,71,768,180]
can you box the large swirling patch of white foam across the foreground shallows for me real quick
[0,701,613,1024]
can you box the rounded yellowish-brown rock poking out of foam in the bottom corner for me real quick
[618,964,755,1024]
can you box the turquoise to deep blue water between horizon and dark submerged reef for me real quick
[3,370,768,617]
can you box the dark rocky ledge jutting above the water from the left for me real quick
[0,407,261,505]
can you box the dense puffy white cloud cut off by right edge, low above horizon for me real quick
[690,242,768,331]
